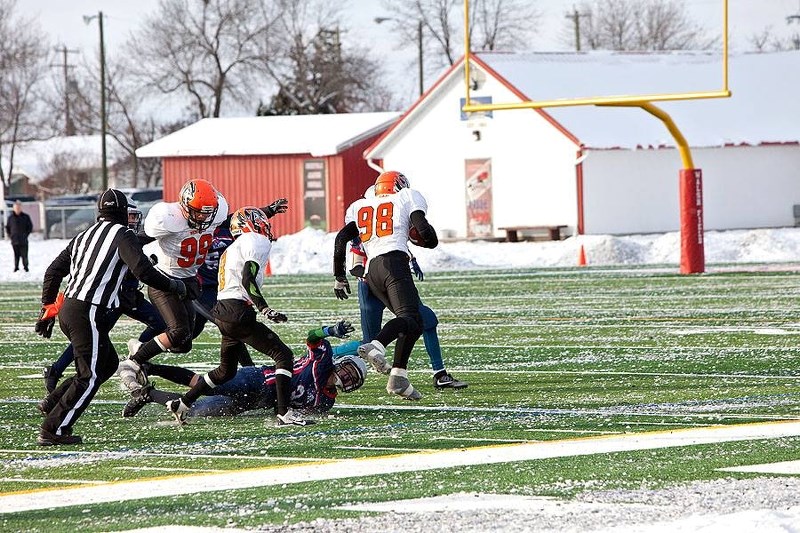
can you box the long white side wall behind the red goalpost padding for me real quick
[583,145,800,234]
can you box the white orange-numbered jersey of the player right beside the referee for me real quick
[144,194,228,278]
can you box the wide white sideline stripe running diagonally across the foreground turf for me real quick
[0,421,800,513]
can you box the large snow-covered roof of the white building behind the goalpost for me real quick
[478,51,800,148]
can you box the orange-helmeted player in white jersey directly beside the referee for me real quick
[119,179,228,383]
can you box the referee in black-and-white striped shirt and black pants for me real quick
[36,189,186,446]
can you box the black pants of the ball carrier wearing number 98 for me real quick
[366,251,422,368]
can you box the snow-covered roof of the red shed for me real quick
[136,111,400,157]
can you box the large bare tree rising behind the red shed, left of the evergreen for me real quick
[127,0,279,118]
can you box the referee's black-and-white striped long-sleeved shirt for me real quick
[42,220,170,308]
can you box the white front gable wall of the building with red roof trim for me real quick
[380,75,578,237]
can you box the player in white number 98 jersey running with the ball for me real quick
[333,171,439,400]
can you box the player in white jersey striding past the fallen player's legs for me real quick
[160,207,313,426]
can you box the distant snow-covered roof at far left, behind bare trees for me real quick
[2,135,111,183]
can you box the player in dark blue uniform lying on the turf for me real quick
[122,320,367,417]
